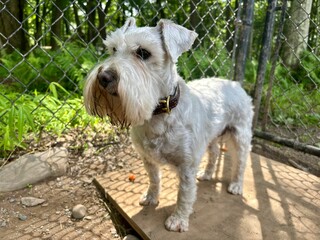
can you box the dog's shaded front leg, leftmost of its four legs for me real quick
[139,159,161,206]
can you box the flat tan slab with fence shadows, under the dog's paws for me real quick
[95,153,320,240]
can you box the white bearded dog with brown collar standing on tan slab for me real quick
[84,18,253,232]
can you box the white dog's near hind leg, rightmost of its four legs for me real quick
[228,126,251,194]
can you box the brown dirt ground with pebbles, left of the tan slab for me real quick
[0,125,320,240]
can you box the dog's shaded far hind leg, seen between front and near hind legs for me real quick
[197,140,220,181]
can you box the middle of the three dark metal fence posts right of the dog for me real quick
[253,0,277,128]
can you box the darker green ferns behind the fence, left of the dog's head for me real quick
[0,42,97,92]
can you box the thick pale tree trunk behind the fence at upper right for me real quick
[281,0,312,68]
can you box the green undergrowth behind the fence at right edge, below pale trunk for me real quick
[262,52,320,128]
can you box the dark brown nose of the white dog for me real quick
[97,70,118,96]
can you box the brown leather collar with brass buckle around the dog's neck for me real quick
[153,85,180,115]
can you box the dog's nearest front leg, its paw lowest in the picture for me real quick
[165,166,197,232]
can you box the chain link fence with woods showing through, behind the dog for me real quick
[0,0,320,158]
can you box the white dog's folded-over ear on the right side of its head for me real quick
[157,19,198,62]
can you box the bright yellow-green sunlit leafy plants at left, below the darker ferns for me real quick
[0,82,97,156]
